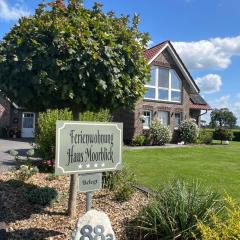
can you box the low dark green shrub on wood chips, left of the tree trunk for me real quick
[26,187,58,206]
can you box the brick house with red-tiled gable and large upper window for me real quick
[114,41,210,141]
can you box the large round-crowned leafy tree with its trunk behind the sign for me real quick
[0,0,149,216]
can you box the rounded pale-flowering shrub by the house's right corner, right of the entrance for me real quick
[178,120,199,143]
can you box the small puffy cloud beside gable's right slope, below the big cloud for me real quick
[195,74,222,93]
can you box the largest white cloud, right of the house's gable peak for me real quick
[173,35,240,69]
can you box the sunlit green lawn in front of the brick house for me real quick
[124,142,240,201]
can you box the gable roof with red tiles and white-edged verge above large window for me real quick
[144,40,200,93]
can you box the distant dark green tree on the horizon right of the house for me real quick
[210,108,237,128]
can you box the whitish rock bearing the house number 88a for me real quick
[72,209,116,240]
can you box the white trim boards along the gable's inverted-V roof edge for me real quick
[148,42,199,93]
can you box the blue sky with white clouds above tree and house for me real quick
[0,0,240,124]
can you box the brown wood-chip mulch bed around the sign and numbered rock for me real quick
[0,172,148,240]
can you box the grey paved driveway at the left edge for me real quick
[0,139,32,173]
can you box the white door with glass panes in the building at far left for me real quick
[22,112,35,138]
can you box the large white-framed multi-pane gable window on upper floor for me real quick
[144,67,182,102]
